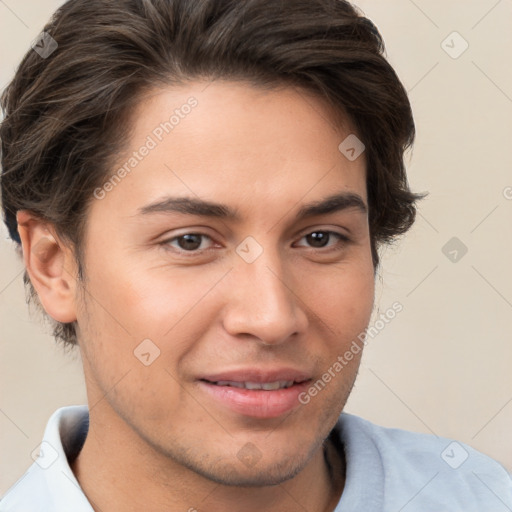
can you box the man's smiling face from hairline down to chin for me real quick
[76,82,374,485]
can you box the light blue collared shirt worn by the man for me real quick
[0,406,512,512]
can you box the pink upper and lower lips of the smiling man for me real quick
[199,368,312,418]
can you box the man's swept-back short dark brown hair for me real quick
[0,0,421,344]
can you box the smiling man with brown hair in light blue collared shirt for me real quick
[0,0,512,512]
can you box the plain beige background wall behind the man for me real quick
[0,0,512,493]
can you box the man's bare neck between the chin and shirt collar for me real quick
[71,408,344,512]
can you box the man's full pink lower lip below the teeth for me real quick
[199,381,309,418]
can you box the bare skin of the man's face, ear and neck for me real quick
[18,81,374,512]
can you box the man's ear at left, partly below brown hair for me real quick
[16,210,78,323]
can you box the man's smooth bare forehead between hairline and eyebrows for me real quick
[90,81,366,222]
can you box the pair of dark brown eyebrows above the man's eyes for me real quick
[138,192,368,221]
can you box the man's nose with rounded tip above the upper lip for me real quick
[223,250,308,345]
